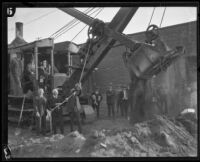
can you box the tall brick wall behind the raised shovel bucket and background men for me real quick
[95,22,197,115]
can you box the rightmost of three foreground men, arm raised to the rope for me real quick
[68,84,82,133]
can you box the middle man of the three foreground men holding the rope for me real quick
[48,89,64,134]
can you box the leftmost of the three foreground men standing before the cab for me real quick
[35,88,47,135]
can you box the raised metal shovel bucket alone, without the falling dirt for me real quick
[125,43,184,79]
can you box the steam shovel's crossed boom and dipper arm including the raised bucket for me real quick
[60,7,183,96]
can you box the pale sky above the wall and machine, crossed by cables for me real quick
[8,7,197,44]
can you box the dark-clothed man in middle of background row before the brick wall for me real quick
[106,83,115,119]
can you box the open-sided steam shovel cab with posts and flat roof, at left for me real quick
[8,38,66,124]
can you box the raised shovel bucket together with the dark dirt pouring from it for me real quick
[124,39,184,124]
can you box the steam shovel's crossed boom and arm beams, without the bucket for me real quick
[59,7,138,94]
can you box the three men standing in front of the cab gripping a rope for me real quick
[34,85,82,135]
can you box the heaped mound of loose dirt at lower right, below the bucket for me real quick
[81,116,197,157]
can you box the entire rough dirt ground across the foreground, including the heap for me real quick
[8,105,197,158]
